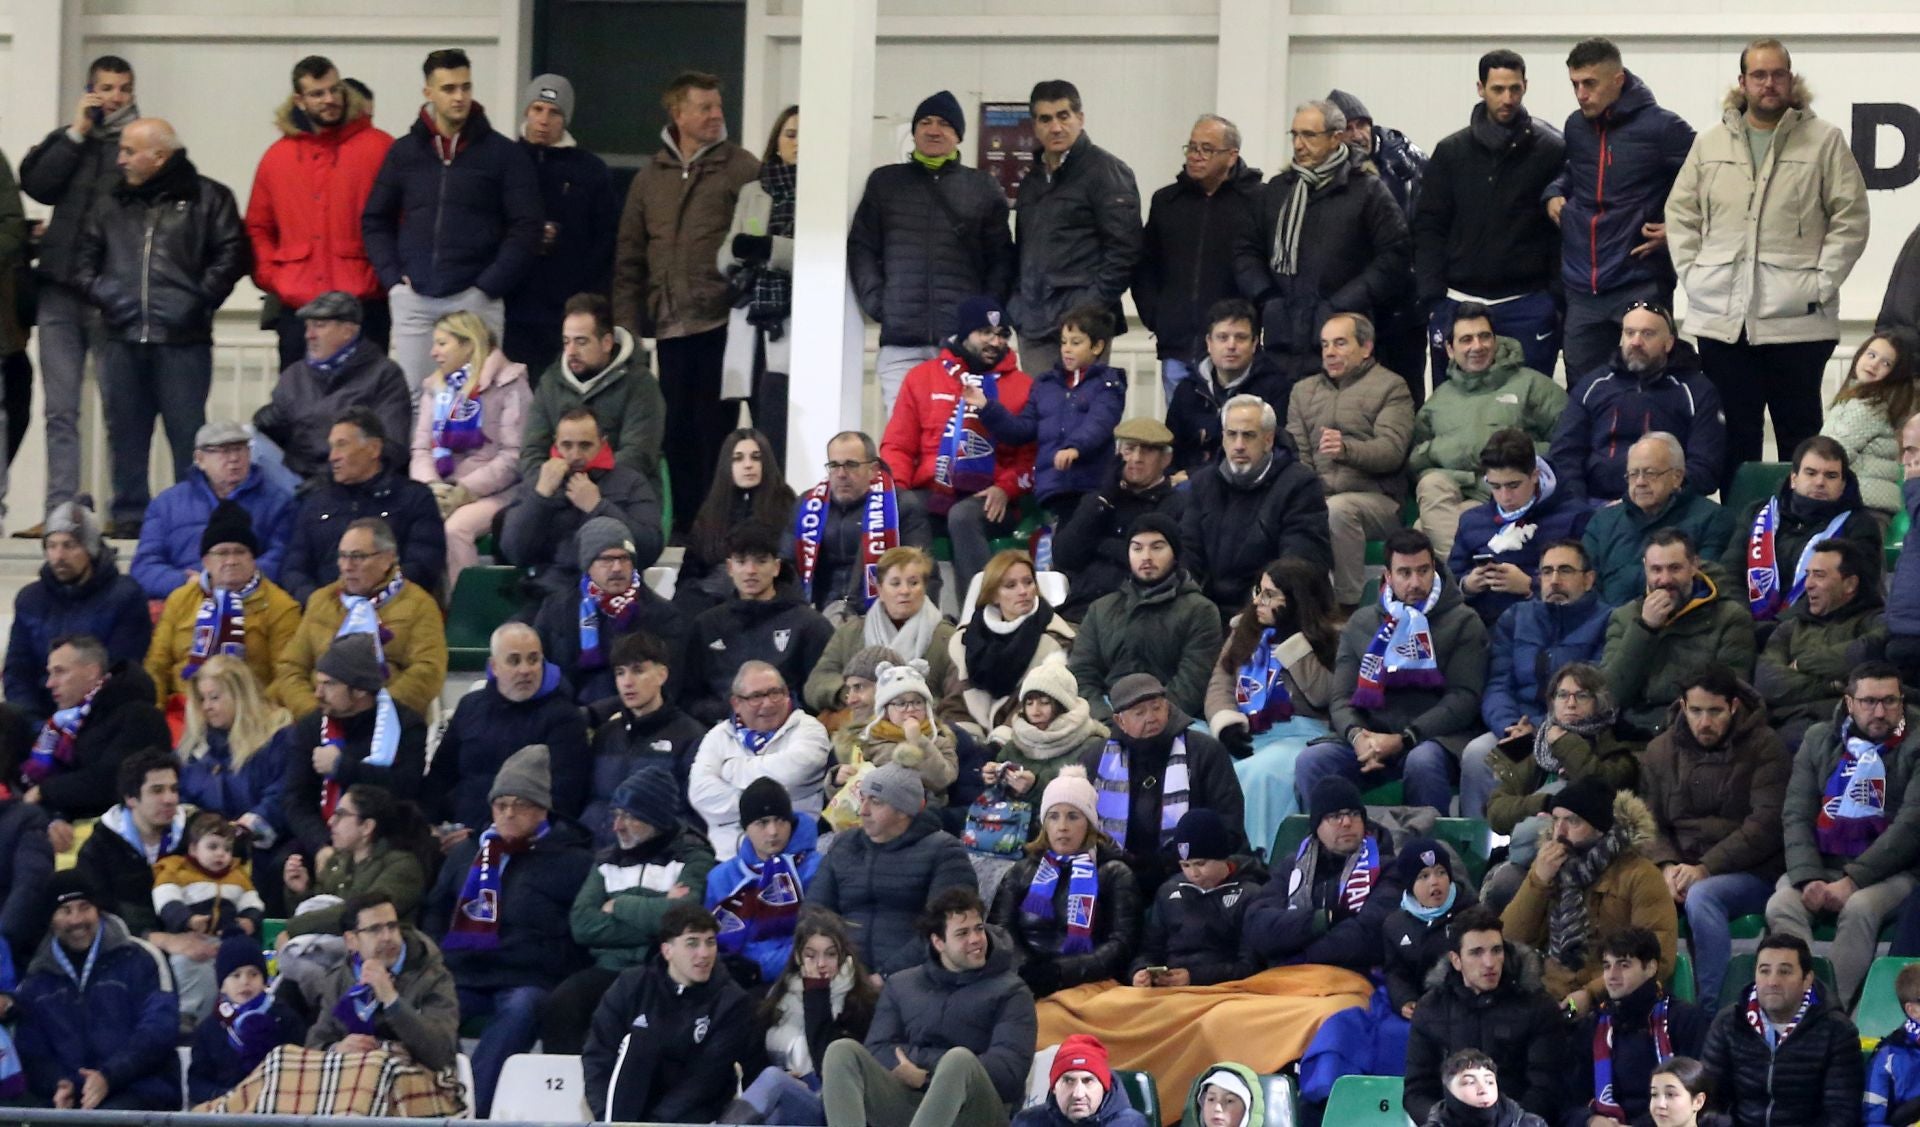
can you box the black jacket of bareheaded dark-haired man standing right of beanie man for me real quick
[1006,132,1140,340]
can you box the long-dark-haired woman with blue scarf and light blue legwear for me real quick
[1206,559,1340,843]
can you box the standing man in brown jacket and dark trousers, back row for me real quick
[612,71,760,528]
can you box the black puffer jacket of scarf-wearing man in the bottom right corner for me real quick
[1701,987,1866,1127]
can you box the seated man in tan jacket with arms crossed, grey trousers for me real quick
[1286,313,1413,609]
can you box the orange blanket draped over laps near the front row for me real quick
[1037,966,1373,1123]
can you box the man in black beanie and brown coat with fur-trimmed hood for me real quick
[1501,776,1680,1016]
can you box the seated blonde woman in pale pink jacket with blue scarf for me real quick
[413,309,534,591]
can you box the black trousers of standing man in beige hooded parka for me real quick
[1697,334,1839,486]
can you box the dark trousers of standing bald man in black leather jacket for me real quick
[100,340,213,524]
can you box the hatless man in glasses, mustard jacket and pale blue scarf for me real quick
[271,516,447,718]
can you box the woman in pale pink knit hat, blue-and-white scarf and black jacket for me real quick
[990,764,1136,998]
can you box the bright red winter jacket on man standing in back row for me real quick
[246,88,394,309]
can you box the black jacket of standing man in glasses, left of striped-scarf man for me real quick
[1133,161,1261,357]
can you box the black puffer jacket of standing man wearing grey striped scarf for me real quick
[1233,161,1413,376]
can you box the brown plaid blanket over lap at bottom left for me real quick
[194,1043,467,1119]
